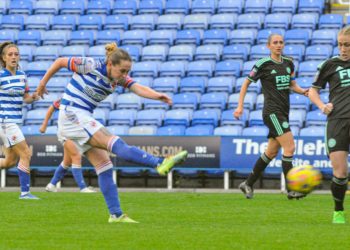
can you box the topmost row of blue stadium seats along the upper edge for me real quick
[0,0,325,15]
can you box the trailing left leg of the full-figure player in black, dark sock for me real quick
[239,138,280,199]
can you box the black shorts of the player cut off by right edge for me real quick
[325,119,350,155]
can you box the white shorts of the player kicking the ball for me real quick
[57,105,103,153]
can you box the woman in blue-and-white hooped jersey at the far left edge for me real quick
[0,42,39,200]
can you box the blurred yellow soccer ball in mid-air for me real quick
[287,165,322,194]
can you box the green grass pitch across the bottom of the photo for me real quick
[0,192,350,250]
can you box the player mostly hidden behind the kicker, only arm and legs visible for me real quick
[39,99,96,193]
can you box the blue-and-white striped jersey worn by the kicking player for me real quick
[61,57,135,112]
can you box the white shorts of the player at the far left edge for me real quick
[0,123,25,148]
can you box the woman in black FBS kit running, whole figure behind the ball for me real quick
[234,34,308,199]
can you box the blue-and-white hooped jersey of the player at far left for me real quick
[0,69,29,124]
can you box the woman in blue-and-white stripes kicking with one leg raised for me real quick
[37,43,187,223]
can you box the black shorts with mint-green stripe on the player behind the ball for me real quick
[263,113,290,138]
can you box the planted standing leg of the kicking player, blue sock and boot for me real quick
[85,148,136,223]
